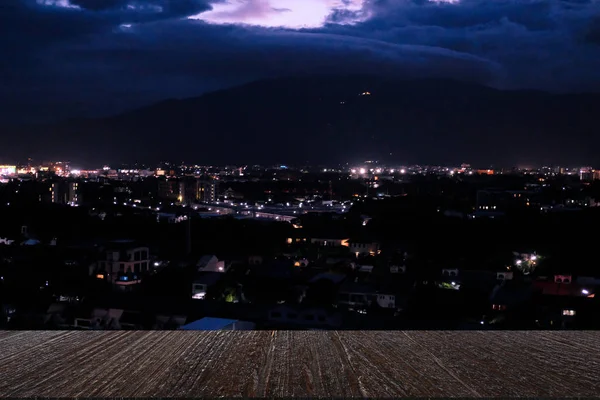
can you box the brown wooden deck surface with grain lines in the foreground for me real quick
[0,331,600,397]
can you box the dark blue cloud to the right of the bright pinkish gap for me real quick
[318,0,600,91]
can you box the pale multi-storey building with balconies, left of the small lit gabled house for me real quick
[92,240,150,286]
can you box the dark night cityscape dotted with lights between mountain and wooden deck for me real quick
[0,160,600,330]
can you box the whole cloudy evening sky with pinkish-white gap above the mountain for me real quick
[0,0,600,123]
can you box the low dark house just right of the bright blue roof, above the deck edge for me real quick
[267,305,342,329]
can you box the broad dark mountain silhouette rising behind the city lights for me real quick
[3,76,600,166]
